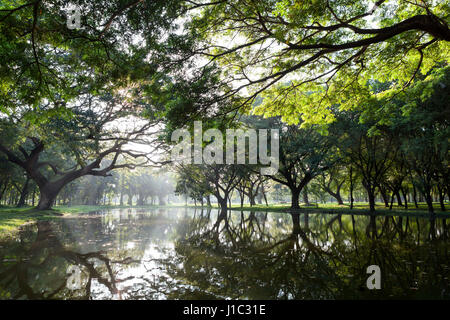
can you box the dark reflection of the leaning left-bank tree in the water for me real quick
[0,221,136,299]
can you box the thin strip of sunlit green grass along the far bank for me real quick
[0,202,450,240]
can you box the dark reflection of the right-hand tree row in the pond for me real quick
[165,213,450,299]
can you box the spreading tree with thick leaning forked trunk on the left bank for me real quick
[0,97,159,210]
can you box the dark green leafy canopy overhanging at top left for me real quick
[0,0,182,121]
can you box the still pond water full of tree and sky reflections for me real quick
[0,208,450,299]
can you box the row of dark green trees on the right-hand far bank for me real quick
[177,68,450,212]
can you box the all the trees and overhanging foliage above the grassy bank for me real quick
[0,0,450,212]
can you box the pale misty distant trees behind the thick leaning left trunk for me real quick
[0,162,174,207]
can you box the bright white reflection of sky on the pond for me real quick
[64,209,289,299]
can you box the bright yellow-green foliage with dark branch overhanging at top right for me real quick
[189,0,450,124]
